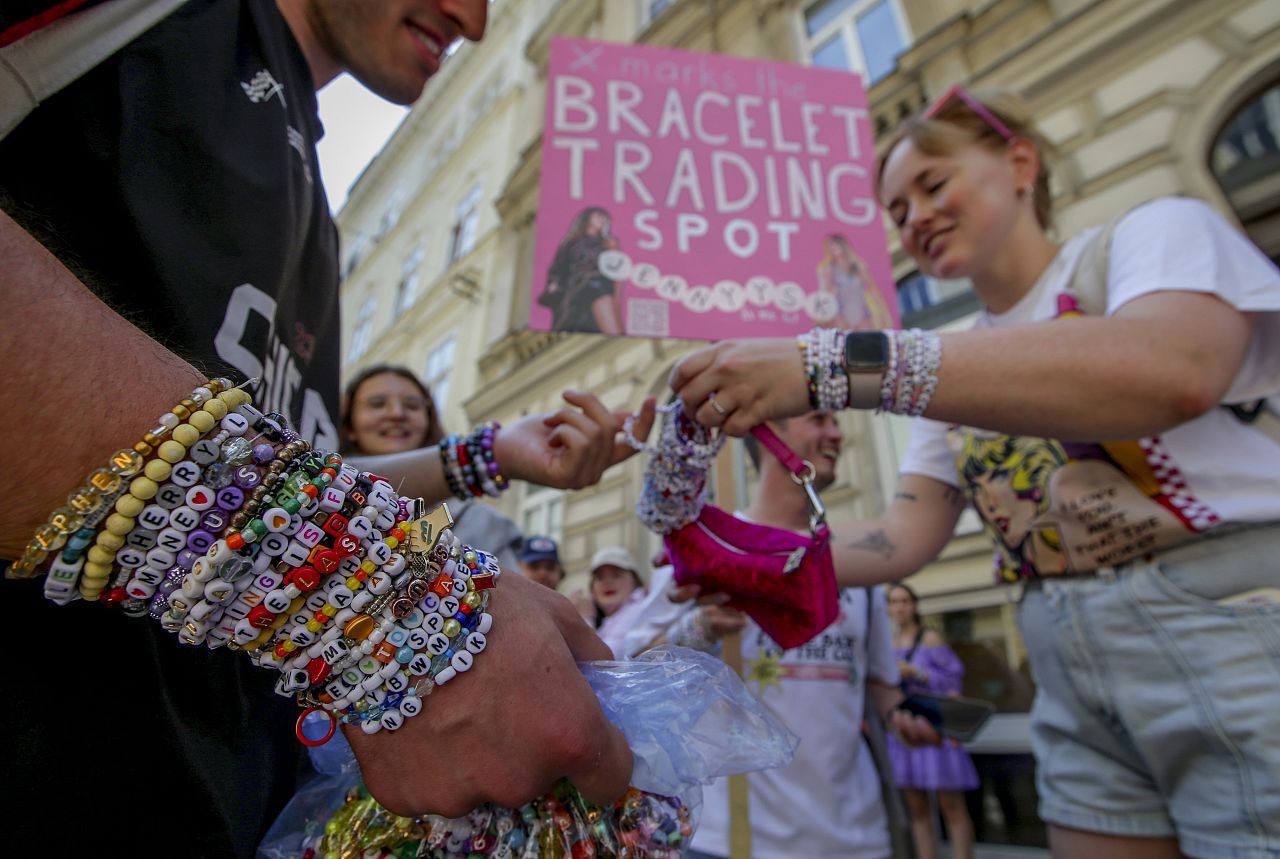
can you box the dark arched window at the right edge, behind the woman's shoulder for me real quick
[1210,79,1280,261]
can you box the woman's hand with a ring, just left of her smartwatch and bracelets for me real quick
[671,337,812,435]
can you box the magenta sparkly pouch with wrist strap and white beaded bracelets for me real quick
[636,402,838,648]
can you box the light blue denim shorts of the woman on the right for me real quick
[1019,525,1280,859]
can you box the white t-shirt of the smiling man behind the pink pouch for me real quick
[628,567,899,859]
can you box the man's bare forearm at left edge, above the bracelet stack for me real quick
[0,213,205,559]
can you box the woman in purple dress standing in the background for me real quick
[888,584,978,859]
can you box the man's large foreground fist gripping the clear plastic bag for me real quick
[344,572,632,817]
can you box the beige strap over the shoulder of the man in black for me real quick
[0,0,186,140]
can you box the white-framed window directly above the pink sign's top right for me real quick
[804,0,909,86]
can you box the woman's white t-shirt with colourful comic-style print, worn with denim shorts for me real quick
[901,197,1280,580]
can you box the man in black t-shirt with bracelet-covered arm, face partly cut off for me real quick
[0,0,640,856]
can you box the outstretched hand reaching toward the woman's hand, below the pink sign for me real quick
[494,390,654,489]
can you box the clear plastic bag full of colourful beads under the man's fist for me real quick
[259,645,797,859]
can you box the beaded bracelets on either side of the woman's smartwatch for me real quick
[796,328,942,417]
